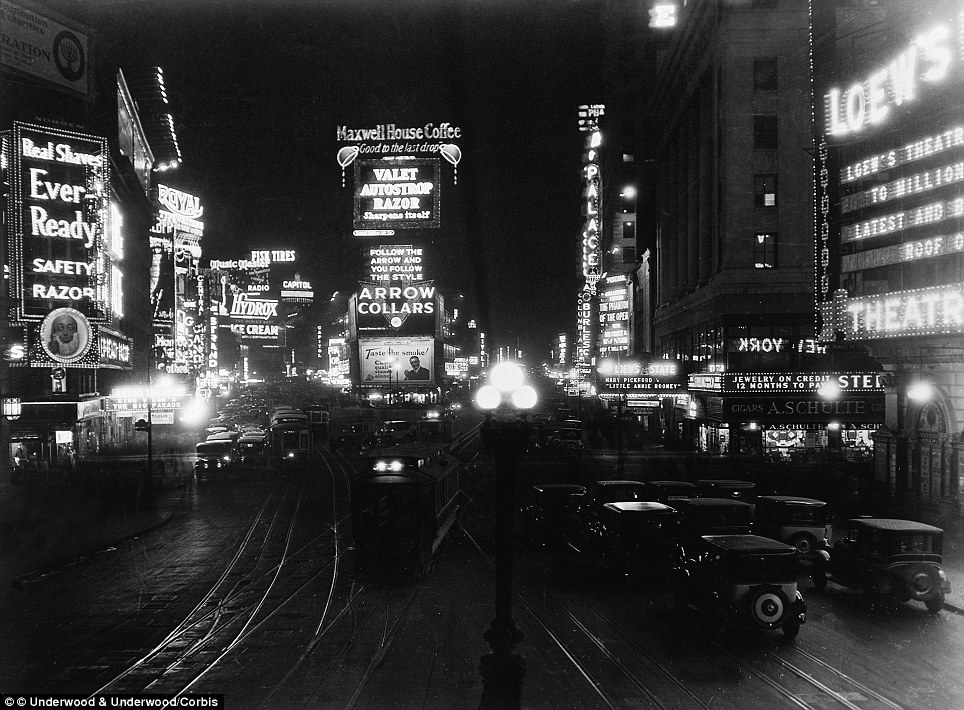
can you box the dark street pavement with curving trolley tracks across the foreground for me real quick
[0,440,964,710]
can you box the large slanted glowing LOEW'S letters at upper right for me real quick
[825,25,956,136]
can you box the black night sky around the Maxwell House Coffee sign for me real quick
[52,0,602,360]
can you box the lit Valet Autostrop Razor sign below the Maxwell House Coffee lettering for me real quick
[354,157,440,229]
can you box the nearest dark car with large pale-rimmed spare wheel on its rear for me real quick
[672,535,807,640]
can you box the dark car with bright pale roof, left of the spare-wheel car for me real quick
[582,500,677,580]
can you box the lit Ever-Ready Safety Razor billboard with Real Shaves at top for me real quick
[8,122,112,322]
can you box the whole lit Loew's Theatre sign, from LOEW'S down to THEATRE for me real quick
[816,0,964,347]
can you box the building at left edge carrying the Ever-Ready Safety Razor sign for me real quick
[0,5,155,471]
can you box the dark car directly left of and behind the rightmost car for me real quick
[753,496,831,562]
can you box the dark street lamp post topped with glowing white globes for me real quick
[475,362,537,708]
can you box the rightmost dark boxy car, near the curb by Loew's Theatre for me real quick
[815,518,951,614]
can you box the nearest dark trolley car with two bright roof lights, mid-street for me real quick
[351,444,459,574]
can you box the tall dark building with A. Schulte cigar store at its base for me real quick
[647,0,882,457]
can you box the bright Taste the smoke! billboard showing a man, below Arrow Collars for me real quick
[358,337,435,387]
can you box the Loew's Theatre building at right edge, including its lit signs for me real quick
[813,0,964,519]
